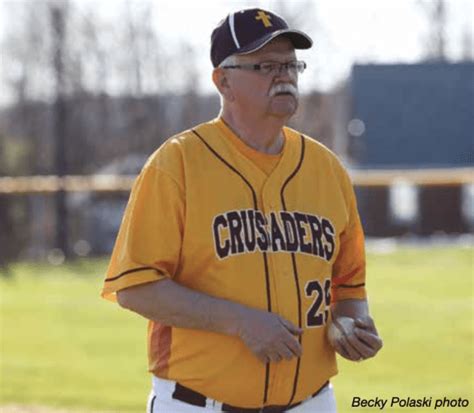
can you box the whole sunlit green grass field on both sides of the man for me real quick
[0,247,474,413]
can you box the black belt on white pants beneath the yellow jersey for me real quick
[173,381,329,413]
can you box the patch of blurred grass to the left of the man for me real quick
[0,260,150,412]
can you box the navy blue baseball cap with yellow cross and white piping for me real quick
[211,9,313,67]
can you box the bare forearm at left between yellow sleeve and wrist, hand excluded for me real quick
[117,279,249,335]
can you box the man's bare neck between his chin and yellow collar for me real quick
[221,111,287,155]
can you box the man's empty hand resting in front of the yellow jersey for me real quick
[237,308,303,363]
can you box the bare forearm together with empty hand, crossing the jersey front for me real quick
[117,279,303,363]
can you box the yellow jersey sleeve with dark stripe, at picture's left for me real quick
[101,162,184,301]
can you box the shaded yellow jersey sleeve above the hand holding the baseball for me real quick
[332,163,367,301]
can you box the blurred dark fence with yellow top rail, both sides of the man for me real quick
[0,168,474,263]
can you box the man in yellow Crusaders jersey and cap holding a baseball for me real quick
[103,9,382,413]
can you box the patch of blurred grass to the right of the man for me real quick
[334,247,474,412]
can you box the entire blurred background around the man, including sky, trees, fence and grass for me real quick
[0,0,474,413]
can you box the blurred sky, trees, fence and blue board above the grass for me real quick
[0,0,474,266]
